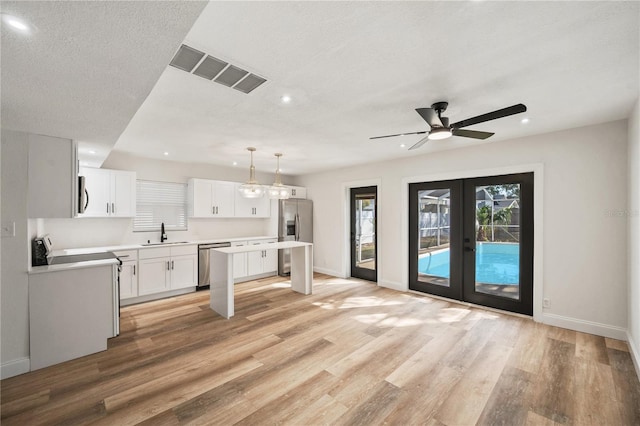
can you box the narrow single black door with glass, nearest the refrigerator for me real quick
[349,186,378,281]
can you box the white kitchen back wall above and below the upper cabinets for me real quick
[39,152,290,249]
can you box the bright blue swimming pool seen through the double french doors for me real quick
[418,243,520,285]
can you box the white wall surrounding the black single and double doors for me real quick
[296,121,627,338]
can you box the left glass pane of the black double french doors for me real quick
[418,189,451,287]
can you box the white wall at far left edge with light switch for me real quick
[0,129,30,378]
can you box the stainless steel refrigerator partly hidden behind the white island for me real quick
[278,198,313,276]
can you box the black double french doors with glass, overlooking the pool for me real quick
[409,173,533,315]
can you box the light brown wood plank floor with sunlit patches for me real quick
[1,275,640,426]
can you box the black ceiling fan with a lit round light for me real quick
[369,102,527,150]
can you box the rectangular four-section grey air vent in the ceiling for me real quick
[169,44,267,93]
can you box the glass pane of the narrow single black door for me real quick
[356,195,376,269]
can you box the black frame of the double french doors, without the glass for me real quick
[408,172,534,315]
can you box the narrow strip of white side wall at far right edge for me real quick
[626,99,640,368]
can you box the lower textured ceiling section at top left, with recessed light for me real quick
[0,1,206,161]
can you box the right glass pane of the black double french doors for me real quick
[475,183,520,300]
